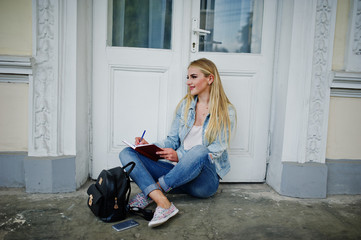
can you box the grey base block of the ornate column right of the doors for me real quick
[280,162,327,198]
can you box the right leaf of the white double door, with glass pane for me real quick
[190,0,276,182]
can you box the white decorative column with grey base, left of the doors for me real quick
[24,0,77,192]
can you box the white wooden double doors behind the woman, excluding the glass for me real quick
[91,0,275,182]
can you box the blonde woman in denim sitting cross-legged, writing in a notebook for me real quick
[119,58,236,227]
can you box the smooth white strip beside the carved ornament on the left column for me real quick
[58,0,78,155]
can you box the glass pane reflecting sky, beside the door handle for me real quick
[199,0,263,53]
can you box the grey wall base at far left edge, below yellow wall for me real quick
[0,152,28,187]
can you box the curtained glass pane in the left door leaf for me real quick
[108,0,172,49]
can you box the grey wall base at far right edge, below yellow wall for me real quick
[326,159,361,194]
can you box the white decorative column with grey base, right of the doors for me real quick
[267,0,337,198]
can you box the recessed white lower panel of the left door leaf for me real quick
[110,66,167,152]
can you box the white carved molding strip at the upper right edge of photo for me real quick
[345,0,361,72]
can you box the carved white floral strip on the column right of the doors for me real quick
[306,0,337,163]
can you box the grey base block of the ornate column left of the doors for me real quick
[24,156,76,193]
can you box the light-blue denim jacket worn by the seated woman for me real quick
[156,97,236,178]
